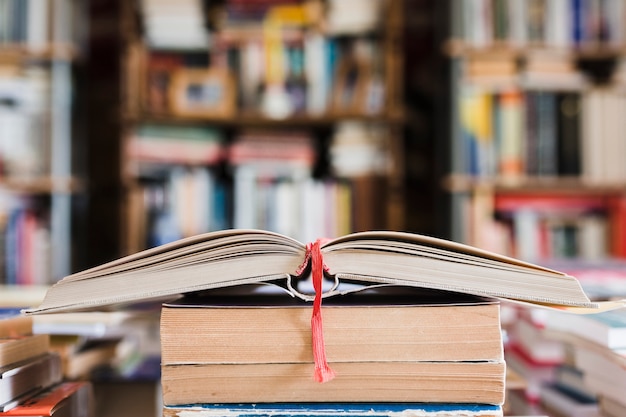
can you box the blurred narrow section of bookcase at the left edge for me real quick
[0,0,81,285]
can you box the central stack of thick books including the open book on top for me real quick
[27,229,608,416]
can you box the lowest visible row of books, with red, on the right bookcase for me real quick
[468,190,622,267]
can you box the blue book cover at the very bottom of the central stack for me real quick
[163,403,503,417]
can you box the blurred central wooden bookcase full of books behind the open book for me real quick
[125,0,403,252]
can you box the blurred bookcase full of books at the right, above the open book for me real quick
[440,0,626,262]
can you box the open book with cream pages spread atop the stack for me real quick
[25,229,616,314]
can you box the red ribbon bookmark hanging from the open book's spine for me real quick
[307,239,335,383]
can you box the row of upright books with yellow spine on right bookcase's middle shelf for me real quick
[458,87,588,181]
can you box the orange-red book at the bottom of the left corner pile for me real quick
[0,381,95,417]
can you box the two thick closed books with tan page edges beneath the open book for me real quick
[160,286,505,405]
